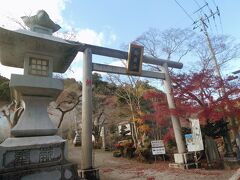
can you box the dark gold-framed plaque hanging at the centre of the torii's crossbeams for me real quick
[127,44,144,75]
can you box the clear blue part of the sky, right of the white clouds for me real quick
[63,0,240,43]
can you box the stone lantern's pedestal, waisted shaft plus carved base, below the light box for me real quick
[0,74,78,180]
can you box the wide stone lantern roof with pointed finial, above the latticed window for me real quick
[0,10,79,73]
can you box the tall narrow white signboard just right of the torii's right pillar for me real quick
[190,119,204,151]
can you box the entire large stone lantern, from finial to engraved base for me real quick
[0,10,78,180]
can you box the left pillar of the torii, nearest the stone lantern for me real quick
[80,48,100,180]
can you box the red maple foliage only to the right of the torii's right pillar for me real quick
[172,69,240,125]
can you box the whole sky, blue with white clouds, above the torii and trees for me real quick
[0,0,240,78]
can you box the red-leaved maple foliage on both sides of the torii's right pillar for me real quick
[144,69,240,145]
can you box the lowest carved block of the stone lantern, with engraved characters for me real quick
[0,136,77,180]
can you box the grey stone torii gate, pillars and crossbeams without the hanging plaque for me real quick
[76,43,186,178]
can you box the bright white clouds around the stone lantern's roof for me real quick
[0,0,117,80]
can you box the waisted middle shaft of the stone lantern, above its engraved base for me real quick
[10,74,63,137]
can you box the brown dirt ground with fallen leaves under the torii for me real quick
[69,146,240,180]
